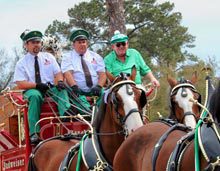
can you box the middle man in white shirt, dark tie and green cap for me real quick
[61,29,106,113]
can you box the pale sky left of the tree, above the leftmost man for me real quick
[0,0,82,50]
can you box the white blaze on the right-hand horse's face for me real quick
[175,88,196,128]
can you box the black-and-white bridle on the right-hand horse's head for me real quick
[170,82,201,123]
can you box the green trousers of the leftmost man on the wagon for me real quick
[23,87,70,135]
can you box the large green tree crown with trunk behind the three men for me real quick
[46,0,196,65]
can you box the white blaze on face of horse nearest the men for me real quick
[118,85,143,134]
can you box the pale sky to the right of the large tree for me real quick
[158,0,220,61]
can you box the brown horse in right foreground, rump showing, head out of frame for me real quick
[113,81,220,171]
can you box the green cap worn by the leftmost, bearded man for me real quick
[20,30,43,42]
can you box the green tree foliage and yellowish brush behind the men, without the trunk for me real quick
[46,0,218,117]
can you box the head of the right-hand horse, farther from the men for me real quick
[167,73,201,128]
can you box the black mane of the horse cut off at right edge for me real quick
[209,81,220,123]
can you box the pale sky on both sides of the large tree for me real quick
[0,0,220,74]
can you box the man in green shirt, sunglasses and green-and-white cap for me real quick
[104,31,160,87]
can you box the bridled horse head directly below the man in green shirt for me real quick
[99,67,147,135]
